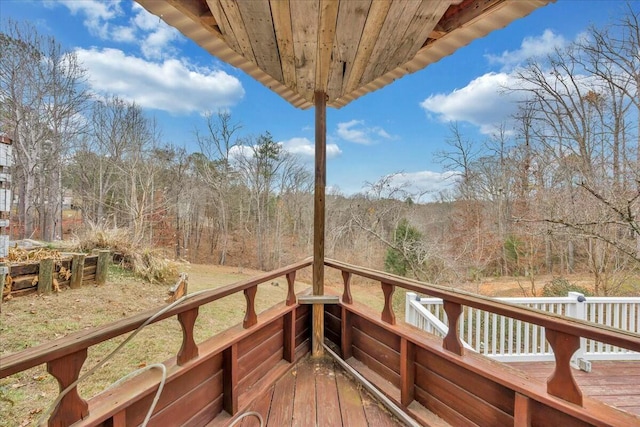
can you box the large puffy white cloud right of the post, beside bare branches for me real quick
[420,73,525,134]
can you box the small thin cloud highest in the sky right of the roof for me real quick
[485,29,567,71]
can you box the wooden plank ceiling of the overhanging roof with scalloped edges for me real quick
[136,0,555,108]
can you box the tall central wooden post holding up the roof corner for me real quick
[311,91,327,357]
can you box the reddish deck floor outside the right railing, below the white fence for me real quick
[509,361,640,415]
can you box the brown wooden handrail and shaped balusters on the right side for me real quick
[325,259,640,406]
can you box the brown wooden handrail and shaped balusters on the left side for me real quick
[0,259,311,426]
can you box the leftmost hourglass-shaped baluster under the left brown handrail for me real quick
[47,348,89,427]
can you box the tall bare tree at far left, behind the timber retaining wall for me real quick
[0,21,88,240]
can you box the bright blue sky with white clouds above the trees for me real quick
[0,0,640,197]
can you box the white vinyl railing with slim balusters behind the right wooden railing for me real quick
[405,292,640,369]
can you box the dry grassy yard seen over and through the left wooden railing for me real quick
[0,264,307,427]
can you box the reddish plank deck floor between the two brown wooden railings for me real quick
[208,357,404,427]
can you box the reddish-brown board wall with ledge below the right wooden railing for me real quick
[325,302,640,426]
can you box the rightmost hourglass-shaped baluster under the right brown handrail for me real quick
[546,328,582,406]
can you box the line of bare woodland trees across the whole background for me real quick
[0,8,640,294]
